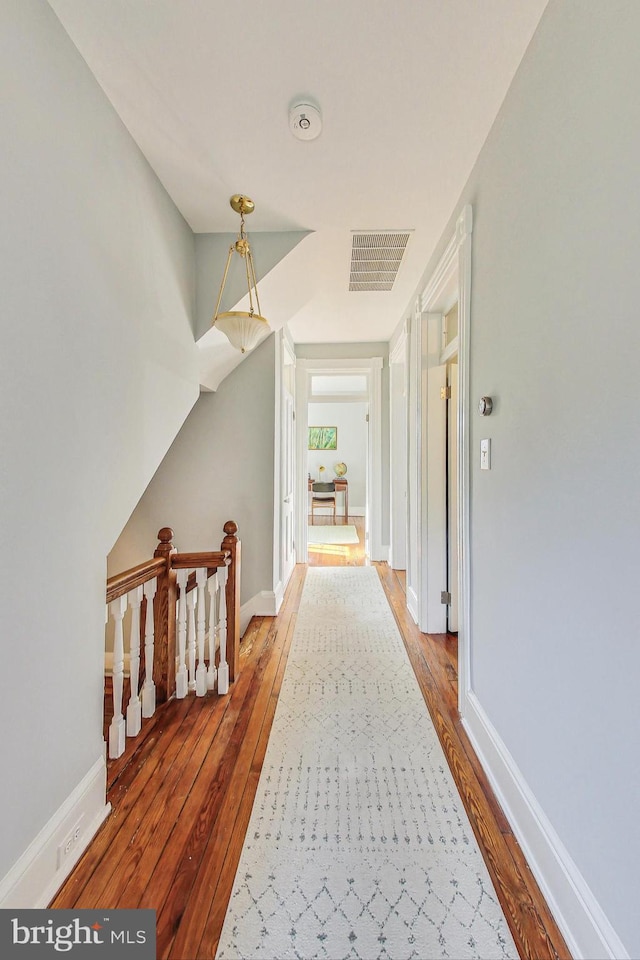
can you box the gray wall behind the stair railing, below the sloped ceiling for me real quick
[109,334,275,603]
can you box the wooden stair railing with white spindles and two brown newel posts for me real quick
[106,520,240,759]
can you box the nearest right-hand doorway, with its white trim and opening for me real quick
[407,206,473,716]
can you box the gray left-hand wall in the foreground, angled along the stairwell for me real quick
[0,0,198,878]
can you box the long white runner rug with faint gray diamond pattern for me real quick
[217,567,518,960]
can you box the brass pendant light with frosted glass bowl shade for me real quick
[211,193,270,353]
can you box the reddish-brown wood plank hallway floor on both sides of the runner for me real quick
[51,518,570,960]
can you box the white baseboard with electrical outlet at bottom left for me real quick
[0,757,111,909]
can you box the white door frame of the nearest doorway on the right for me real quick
[412,205,473,716]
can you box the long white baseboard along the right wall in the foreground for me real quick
[462,691,630,960]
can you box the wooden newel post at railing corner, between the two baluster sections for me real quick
[153,527,178,703]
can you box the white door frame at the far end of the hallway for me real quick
[295,357,389,563]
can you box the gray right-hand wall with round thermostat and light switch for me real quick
[408,0,640,957]
